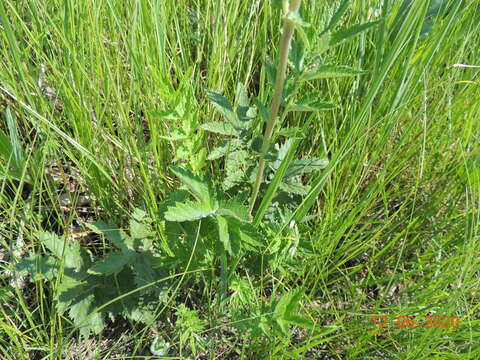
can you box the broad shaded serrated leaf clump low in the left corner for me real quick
[16,214,166,337]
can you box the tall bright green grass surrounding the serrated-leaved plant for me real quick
[0,0,480,360]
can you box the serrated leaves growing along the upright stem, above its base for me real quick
[203,1,380,226]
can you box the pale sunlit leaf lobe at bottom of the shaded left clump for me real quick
[68,294,105,339]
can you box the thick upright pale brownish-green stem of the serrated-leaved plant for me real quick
[250,0,301,213]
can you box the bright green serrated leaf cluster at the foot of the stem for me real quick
[163,167,264,299]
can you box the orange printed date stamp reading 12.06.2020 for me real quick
[372,315,460,329]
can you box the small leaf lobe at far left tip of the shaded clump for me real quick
[15,255,58,281]
